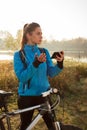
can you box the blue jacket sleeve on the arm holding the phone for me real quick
[45,49,62,77]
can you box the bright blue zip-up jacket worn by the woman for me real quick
[14,44,62,96]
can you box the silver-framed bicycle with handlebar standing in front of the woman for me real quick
[0,88,81,130]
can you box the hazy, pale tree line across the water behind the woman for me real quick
[0,29,87,51]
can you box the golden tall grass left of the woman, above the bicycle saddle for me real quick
[0,61,18,91]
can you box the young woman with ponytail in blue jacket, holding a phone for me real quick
[14,23,64,130]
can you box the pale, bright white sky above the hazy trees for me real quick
[0,0,87,40]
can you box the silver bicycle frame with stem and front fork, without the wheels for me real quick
[0,90,60,130]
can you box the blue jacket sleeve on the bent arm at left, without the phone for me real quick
[14,52,37,83]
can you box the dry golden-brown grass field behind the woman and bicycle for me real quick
[0,60,87,130]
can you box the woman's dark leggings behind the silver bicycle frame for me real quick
[18,96,54,130]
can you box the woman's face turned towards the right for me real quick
[27,27,42,44]
